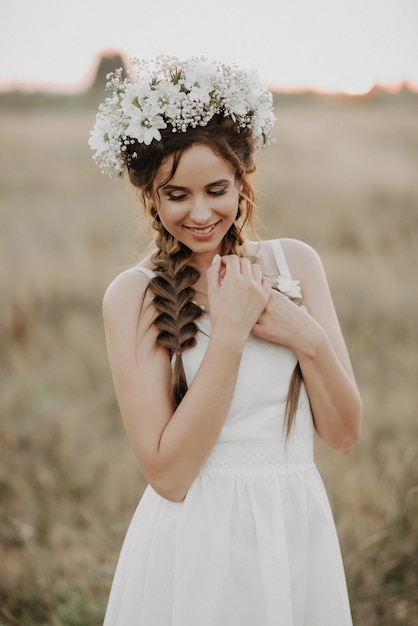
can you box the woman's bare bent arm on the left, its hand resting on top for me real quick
[103,251,270,501]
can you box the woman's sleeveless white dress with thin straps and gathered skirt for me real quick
[104,240,352,626]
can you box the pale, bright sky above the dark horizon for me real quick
[0,0,418,93]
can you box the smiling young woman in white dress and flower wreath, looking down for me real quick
[90,58,361,626]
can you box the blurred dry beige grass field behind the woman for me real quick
[0,90,418,626]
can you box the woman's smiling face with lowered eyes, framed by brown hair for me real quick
[153,144,239,265]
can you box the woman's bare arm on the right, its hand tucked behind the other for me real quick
[253,239,362,453]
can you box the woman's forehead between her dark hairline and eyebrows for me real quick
[155,144,235,187]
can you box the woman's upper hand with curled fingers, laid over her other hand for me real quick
[207,254,271,343]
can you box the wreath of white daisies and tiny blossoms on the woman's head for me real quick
[89,56,275,178]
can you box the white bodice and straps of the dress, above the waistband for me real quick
[135,239,313,451]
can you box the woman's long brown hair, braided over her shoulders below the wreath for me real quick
[125,115,302,439]
